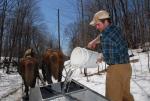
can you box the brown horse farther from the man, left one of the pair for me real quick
[20,49,38,98]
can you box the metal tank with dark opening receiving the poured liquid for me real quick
[29,80,108,101]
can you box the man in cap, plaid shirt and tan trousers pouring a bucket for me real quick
[87,10,134,101]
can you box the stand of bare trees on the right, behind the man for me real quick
[64,0,150,48]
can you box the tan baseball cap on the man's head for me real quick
[90,10,110,26]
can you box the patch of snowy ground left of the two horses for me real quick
[0,70,22,101]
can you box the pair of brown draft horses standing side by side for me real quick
[15,49,64,98]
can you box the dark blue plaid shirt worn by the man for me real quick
[101,25,129,65]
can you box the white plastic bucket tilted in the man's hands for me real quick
[70,47,100,68]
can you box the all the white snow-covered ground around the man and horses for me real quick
[0,50,150,101]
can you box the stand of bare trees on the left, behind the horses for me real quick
[0,0,53,61]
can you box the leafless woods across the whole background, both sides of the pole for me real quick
[0,0,150,60]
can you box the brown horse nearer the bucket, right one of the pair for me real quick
[42,49,64,84]
